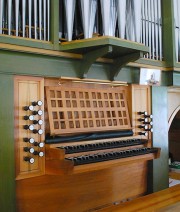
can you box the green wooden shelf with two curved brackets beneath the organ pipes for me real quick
[60,36,149,80]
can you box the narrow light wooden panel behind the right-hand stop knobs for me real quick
[132,85,151,139]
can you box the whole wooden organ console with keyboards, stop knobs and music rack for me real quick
[15,77,160,212]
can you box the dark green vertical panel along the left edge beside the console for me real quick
[0,74,15,212]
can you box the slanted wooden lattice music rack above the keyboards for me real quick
[46,85,131,135]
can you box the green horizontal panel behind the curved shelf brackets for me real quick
[0,50,139,83]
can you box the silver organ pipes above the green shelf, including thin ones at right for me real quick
[59,0,163,60]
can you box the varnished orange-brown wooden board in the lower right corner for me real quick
[99,184,180,212]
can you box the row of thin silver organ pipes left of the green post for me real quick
[0,0,50,41]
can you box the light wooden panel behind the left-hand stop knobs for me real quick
[14,77,44,179]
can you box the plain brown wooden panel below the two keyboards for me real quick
[16,162,147,212]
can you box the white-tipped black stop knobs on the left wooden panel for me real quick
[23,101,44,164]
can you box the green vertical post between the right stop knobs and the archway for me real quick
[149,86,169,192]
